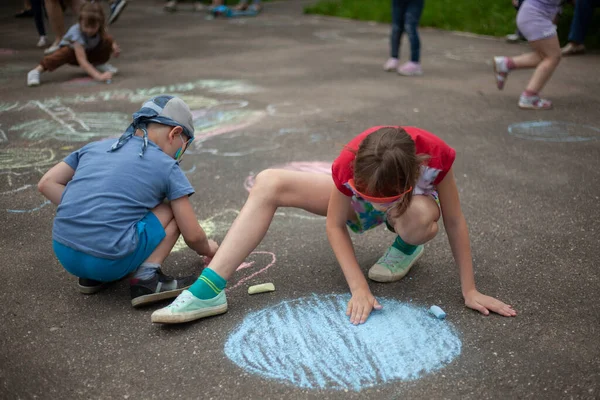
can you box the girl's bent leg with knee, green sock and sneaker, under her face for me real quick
[369,192,441,282]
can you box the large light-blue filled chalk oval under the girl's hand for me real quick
[225,294,461,391]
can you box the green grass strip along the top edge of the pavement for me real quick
[304,0,600,48]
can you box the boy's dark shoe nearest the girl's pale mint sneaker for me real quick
[130,269,198,307]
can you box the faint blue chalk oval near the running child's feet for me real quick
[508,121,600,142]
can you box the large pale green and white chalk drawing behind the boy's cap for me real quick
[0,80,265,142]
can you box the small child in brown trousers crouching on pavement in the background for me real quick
[27,2,121,86]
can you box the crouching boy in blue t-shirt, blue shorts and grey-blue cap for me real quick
[38,95,218,307]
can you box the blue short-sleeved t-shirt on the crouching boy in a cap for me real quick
[52,136,194,259]
